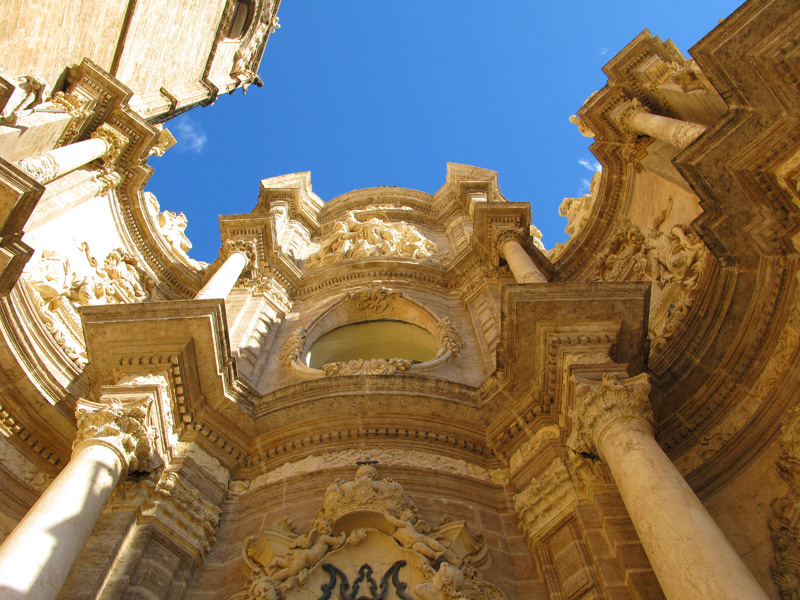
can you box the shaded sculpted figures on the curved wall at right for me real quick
[596,219,712,352]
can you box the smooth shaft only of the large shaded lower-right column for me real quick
[597,421,767,600]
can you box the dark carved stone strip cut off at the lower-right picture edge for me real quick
[769,398,800,600]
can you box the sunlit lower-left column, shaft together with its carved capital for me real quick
[0,402,153,600]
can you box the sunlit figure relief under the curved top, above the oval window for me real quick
[306,211,439,267]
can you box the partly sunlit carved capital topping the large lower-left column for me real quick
[72,398,155,472]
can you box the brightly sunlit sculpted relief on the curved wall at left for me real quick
[22,242,155,367]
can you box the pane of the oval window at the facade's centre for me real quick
[306,320,439,369]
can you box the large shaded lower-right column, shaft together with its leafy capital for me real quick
[568,373,767,600]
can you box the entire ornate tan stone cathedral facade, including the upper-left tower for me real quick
[0,0,800,600]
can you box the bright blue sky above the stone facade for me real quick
[147,0,739,262]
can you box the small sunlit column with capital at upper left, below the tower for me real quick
[17,124,128,185]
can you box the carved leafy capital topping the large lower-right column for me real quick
[567,373,654,454]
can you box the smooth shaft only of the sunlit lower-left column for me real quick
[0,444,124,600]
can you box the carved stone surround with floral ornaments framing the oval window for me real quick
[279,284,466,377]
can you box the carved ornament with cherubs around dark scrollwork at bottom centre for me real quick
[230,465,505,600]
